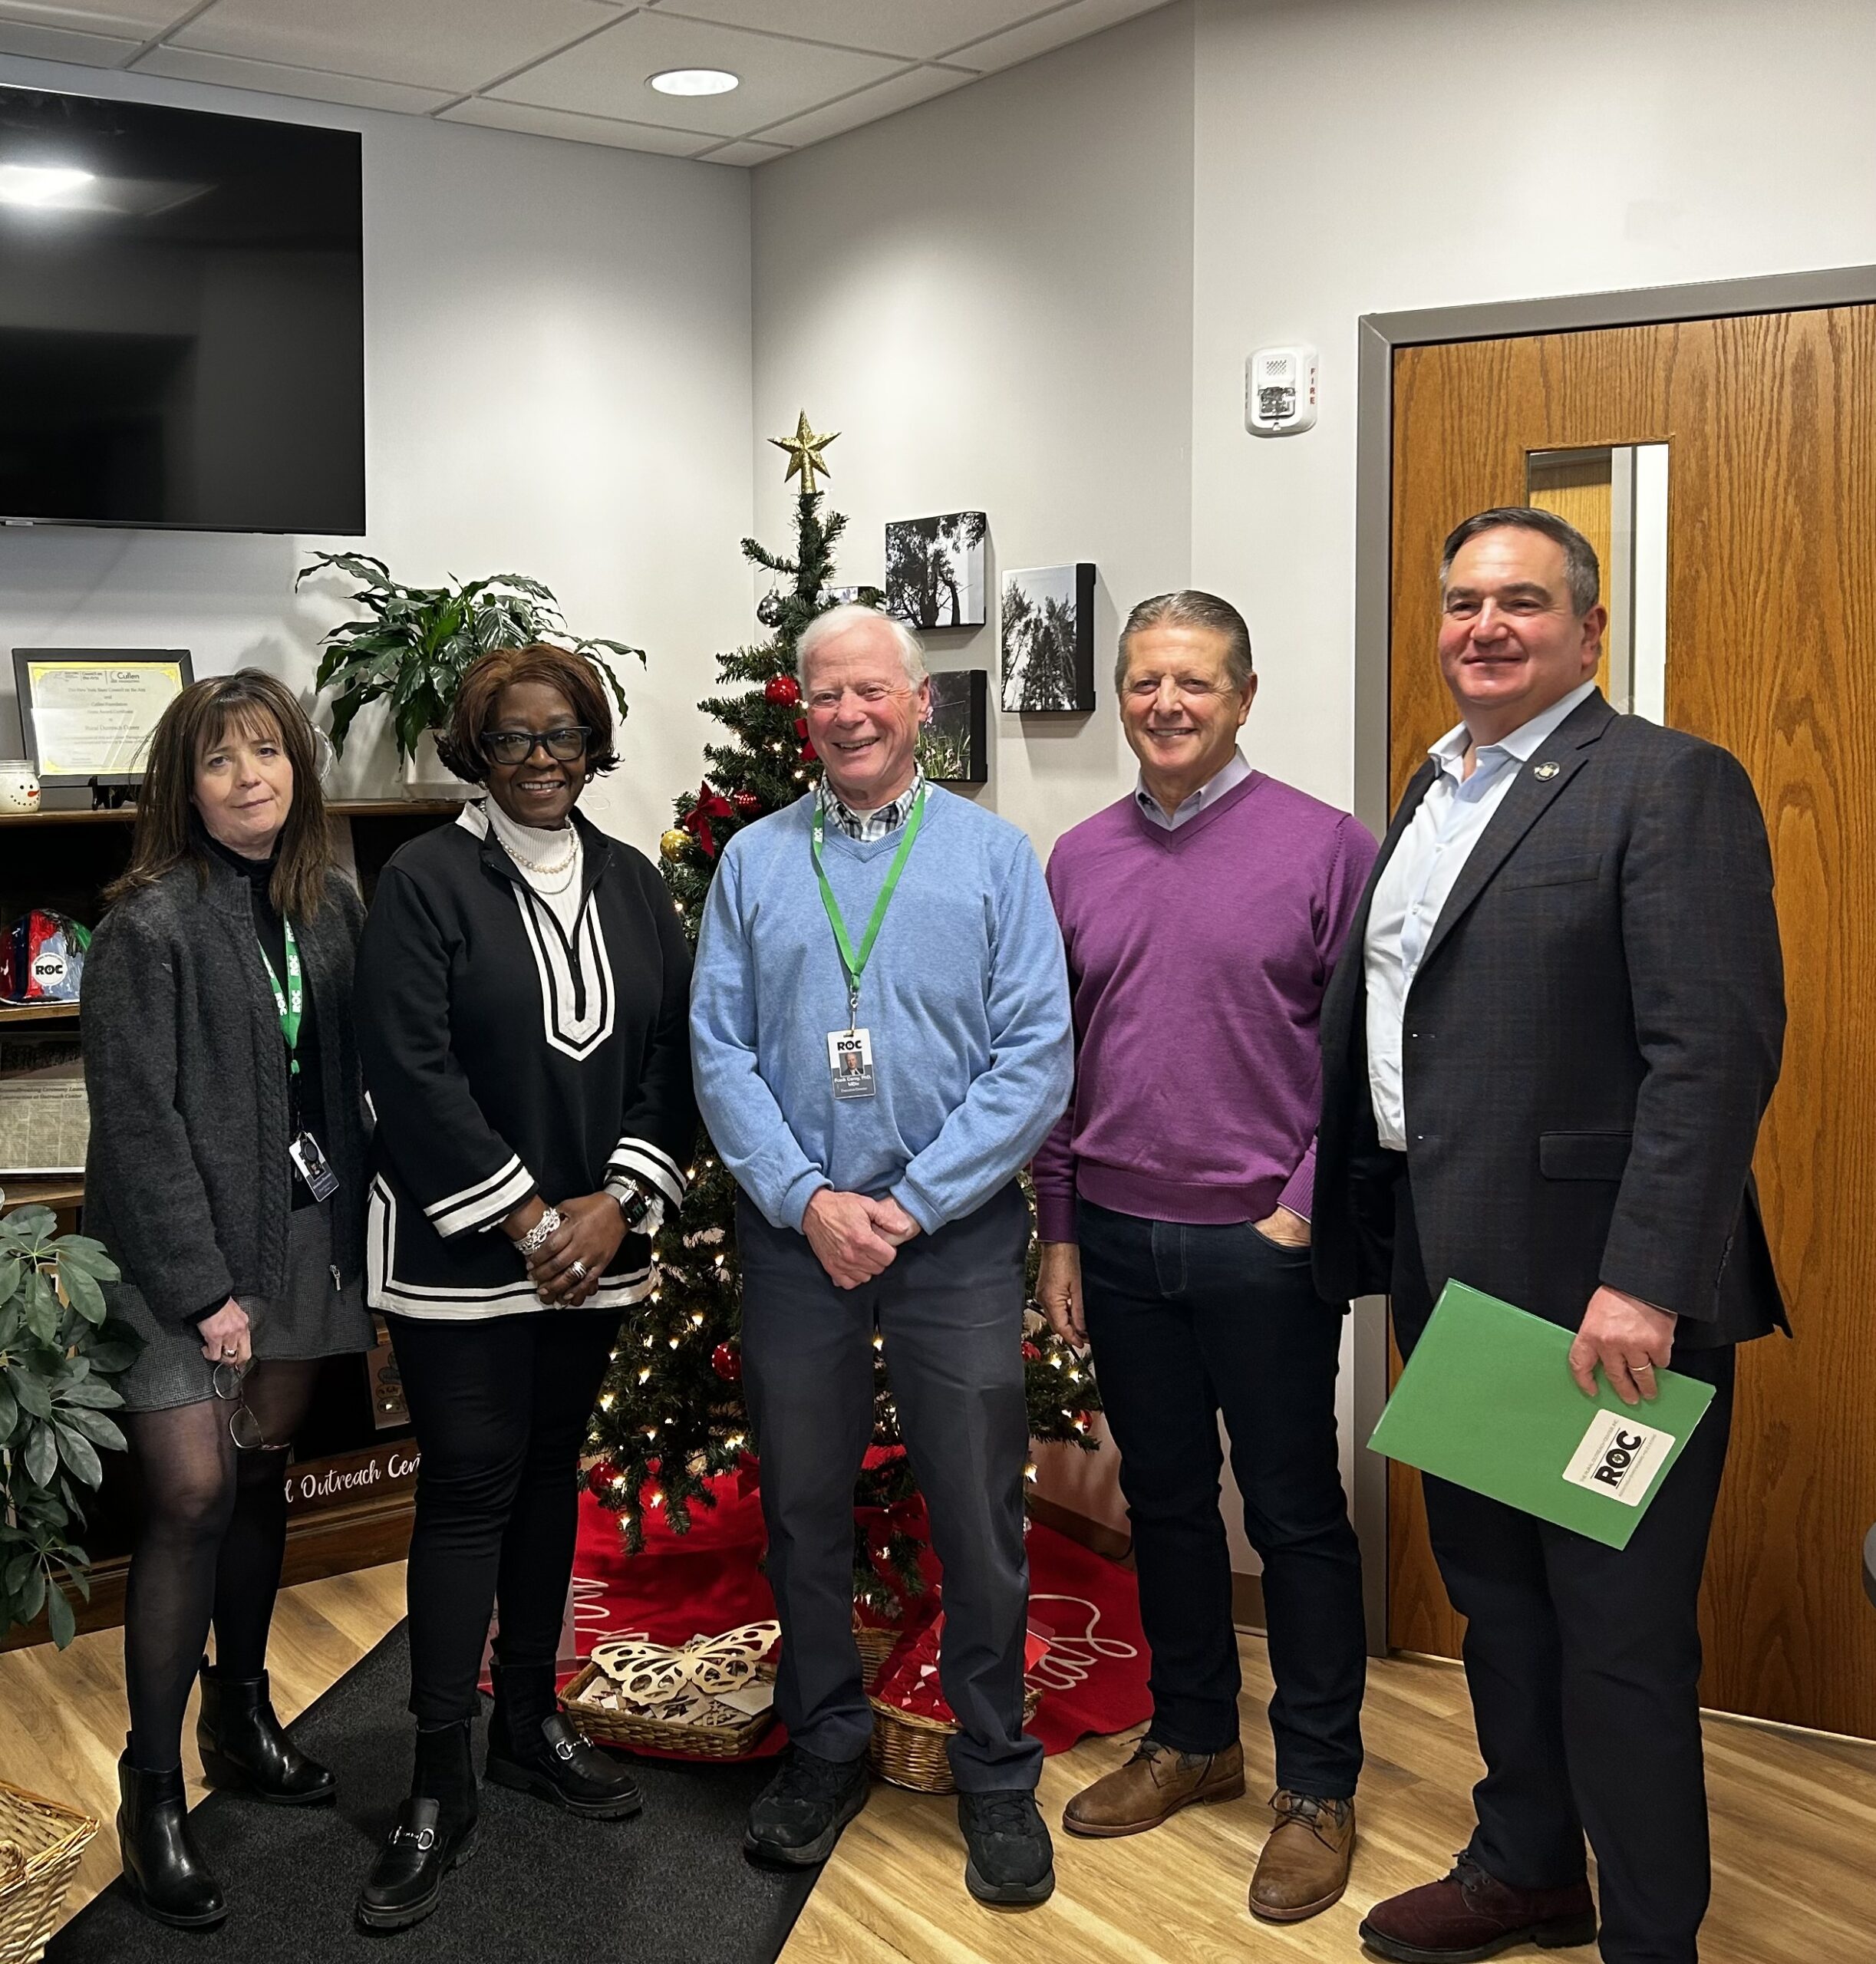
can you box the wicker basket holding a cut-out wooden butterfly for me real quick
[560,1623,782,1760]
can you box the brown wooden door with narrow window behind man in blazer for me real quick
[1389,306,1876,1736]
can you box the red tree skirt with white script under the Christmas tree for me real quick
[574,1475,1153,1754]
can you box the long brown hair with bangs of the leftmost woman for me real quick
[104,667,332,921]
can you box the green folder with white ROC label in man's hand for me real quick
[1367,1283,1713,1547]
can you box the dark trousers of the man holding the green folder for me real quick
[1393,1163,1733,1964]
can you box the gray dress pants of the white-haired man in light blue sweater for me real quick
[737,1185,1043,1793]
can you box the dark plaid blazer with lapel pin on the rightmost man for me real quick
[1312,695,1785,1347]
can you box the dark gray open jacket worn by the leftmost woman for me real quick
[81,856,365,1323]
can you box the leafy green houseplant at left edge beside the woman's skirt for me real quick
[0,1208,140,1649]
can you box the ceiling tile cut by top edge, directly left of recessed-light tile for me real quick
[171,0,621,94]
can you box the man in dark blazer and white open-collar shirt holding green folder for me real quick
[1314,509,1785,1964]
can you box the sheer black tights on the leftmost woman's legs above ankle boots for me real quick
[122,1357,322,1774]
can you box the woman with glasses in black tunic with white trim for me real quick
[358,644,697,1930]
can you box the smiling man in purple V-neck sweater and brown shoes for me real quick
[1035,593,1375,1923]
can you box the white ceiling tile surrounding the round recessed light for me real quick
[489,14,902,136]
